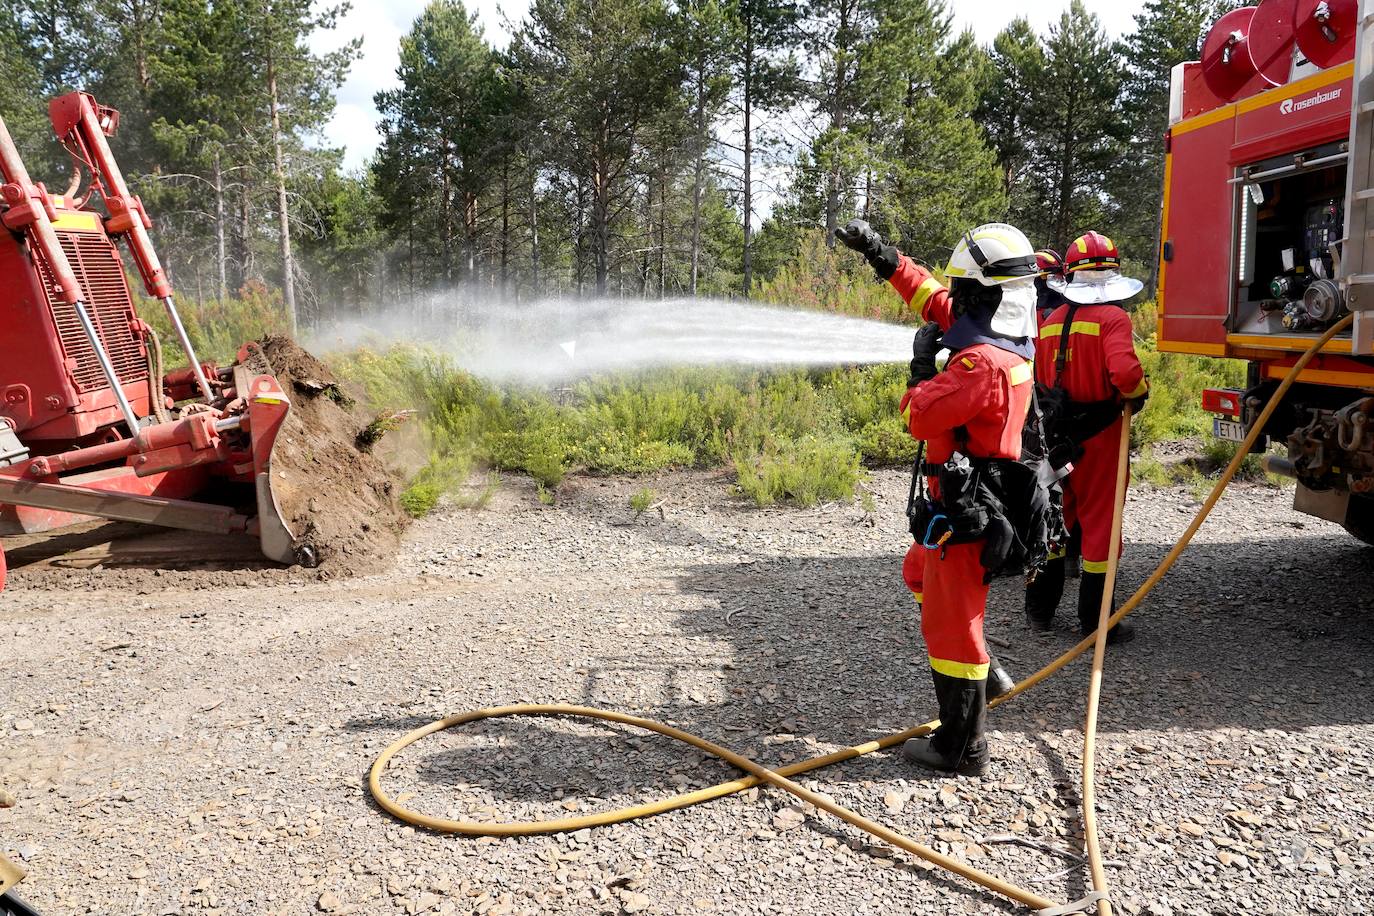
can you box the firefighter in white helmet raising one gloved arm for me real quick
[835,220,1036,775]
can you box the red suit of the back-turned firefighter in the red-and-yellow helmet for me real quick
[1036,304,1147,573]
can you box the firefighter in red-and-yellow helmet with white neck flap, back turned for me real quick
[1026,232,1149,643]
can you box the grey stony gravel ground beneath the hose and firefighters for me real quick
[0,472,1374,916]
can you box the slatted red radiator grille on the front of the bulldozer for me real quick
[38,231,148,391]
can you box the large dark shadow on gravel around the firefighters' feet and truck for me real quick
[671,536,1374,744]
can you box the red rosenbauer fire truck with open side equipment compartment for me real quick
[1157,0,1374,544]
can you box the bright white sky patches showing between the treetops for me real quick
[315,0,1143,169]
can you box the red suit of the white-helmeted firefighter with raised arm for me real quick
[890,257,1033,680]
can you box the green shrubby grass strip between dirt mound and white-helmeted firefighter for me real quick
[333,346,915,505]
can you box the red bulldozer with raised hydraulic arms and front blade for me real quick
[0,92,316,589]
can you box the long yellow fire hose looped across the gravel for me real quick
[367,314,1353,915]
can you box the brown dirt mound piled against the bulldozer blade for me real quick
[253,336,408,575]
